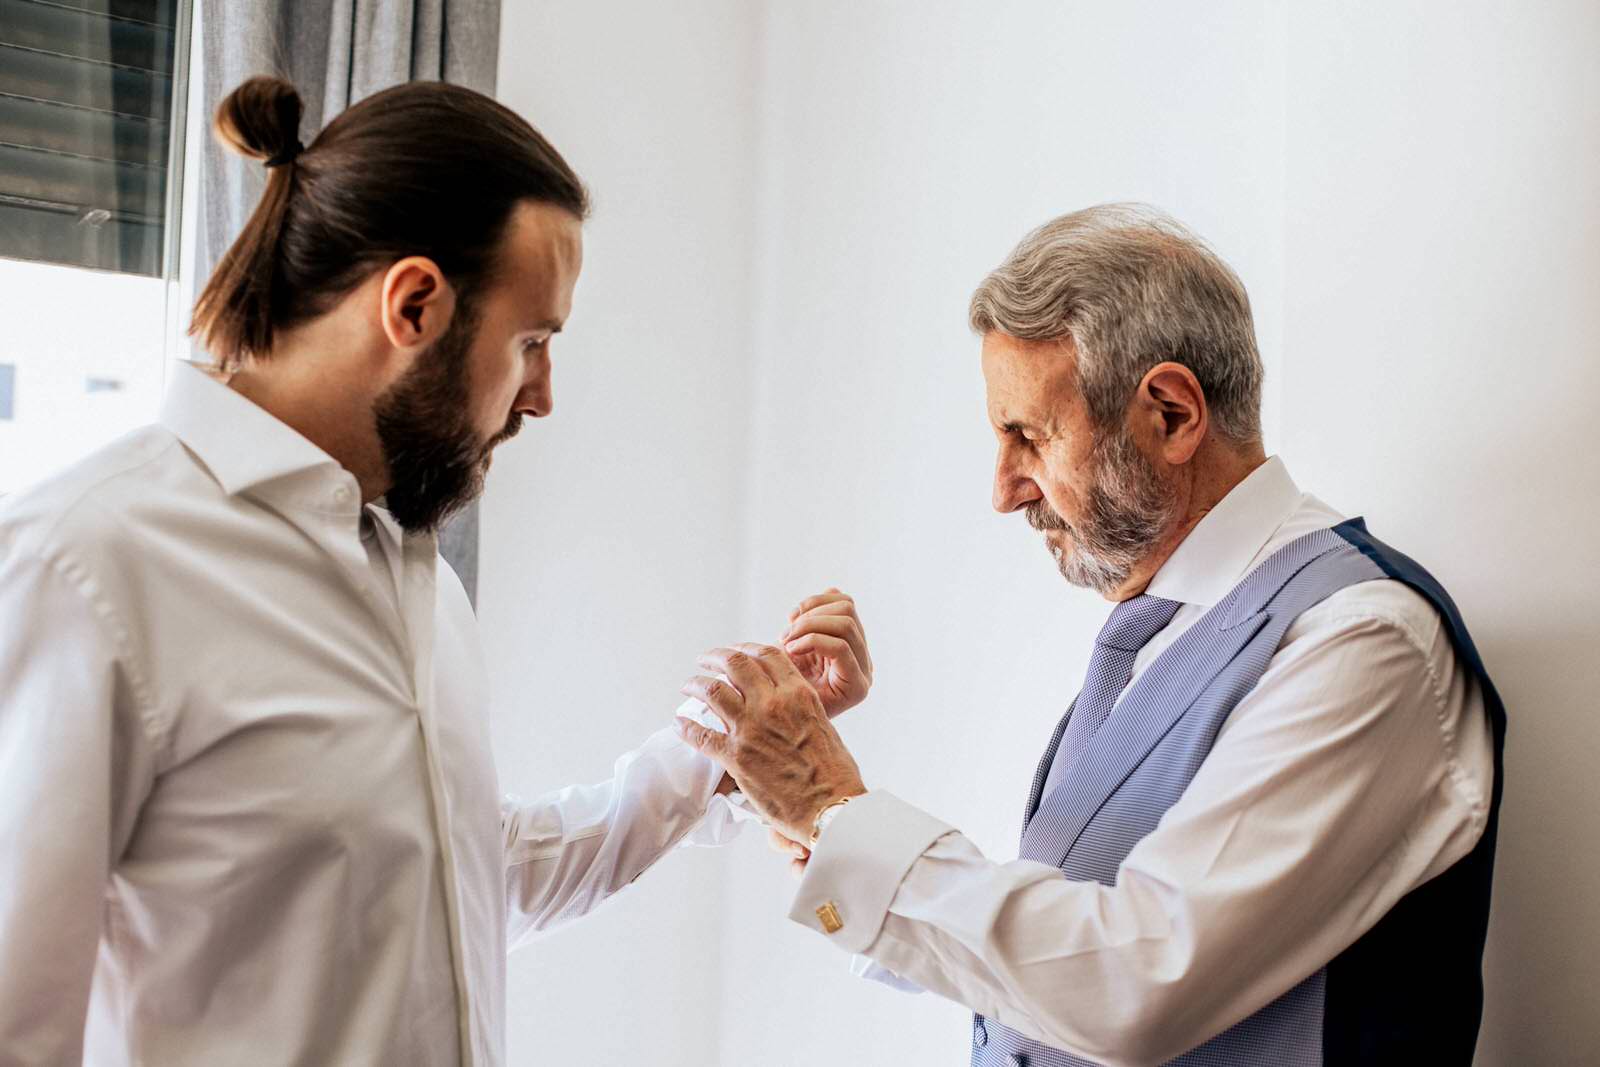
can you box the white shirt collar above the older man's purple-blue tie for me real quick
[1144,456,1304,606]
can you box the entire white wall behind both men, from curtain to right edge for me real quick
[483,0,1600,1067]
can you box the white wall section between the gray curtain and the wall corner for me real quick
[480,0,755,1067]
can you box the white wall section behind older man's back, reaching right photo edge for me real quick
[1278,0,1600,1067]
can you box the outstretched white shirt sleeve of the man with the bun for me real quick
[501,726,723,947]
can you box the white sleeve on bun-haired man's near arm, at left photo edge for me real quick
[0,547,154,1065]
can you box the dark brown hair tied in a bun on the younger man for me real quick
[189,77,589,368]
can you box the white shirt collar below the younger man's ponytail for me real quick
[160,362,344,496]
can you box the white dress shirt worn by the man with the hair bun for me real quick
[0,366,722,1067]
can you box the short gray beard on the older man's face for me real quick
[1027,429,1178,595]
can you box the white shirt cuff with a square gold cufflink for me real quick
[789,790,952,952]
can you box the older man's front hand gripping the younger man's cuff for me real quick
[678,645,867,841]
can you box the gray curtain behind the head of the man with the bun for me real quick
[198,0,501,605]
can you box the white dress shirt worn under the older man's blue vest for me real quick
[792,459,1493,1064]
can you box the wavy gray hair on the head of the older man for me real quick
[968,203,1262,445]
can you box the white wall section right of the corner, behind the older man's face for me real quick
[722,0,1283,1067]
